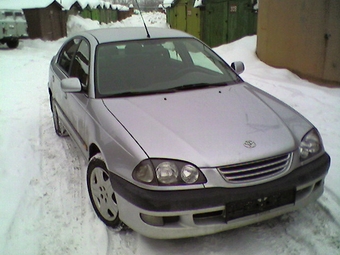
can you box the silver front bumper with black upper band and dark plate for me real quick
[110,153,330,239]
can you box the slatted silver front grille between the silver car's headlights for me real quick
[218,153,292,183]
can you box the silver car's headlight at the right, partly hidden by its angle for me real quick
[299,129,322,160]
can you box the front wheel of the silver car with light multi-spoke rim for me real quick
[86,154,126,231]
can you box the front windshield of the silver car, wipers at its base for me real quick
[95,38,241,97]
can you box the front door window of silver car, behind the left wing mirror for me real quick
[70,40,90,89]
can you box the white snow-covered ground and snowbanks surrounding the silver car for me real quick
[0,13,340,255]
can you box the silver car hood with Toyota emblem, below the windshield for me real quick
[103,83,311,167]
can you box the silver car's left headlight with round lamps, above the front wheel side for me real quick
[132,159,206,186]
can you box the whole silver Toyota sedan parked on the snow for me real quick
[48,27,330,239]
